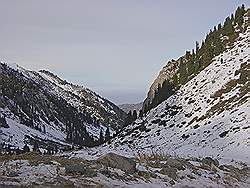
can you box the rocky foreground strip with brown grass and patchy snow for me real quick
[0,153,250,188]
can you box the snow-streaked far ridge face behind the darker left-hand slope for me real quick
[39,70,126,130]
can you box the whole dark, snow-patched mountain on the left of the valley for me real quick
[0,63,126,151]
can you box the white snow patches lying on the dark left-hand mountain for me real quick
[0,57,125,147]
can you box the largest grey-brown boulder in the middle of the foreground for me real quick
[97,153,136,173]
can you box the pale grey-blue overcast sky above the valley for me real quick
[0,0,250,104]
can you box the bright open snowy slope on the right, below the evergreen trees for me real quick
[66,16,250,164]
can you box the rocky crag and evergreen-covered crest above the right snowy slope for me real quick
[143,5,247,112]
